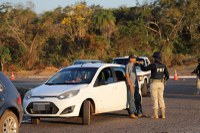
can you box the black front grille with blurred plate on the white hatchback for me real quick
[26,102,59,114]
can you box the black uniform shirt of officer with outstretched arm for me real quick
[141,62,169,80]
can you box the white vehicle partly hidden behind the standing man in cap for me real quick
[112,56,151,96]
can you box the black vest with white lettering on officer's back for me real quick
[151,63,165,79]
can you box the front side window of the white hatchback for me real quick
[96,68,114,85]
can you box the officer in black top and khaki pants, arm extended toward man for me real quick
[141,52,169,119]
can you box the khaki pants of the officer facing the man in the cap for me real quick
[150,81,165,109]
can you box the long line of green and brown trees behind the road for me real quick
[0,0,200,71]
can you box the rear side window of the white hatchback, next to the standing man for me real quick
[113,67,125,82]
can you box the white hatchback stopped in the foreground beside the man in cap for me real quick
[23,63,127,125]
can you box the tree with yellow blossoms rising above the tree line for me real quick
[61,3,93,42]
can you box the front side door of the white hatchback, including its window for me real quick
[92,68,118,113]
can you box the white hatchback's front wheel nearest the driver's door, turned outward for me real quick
[82,100,91,125]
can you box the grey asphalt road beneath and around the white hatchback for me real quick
[14,79,200,133]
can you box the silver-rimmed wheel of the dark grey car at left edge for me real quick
[0,110,19,133]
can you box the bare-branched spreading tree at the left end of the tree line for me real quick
[4,6,53,69]
